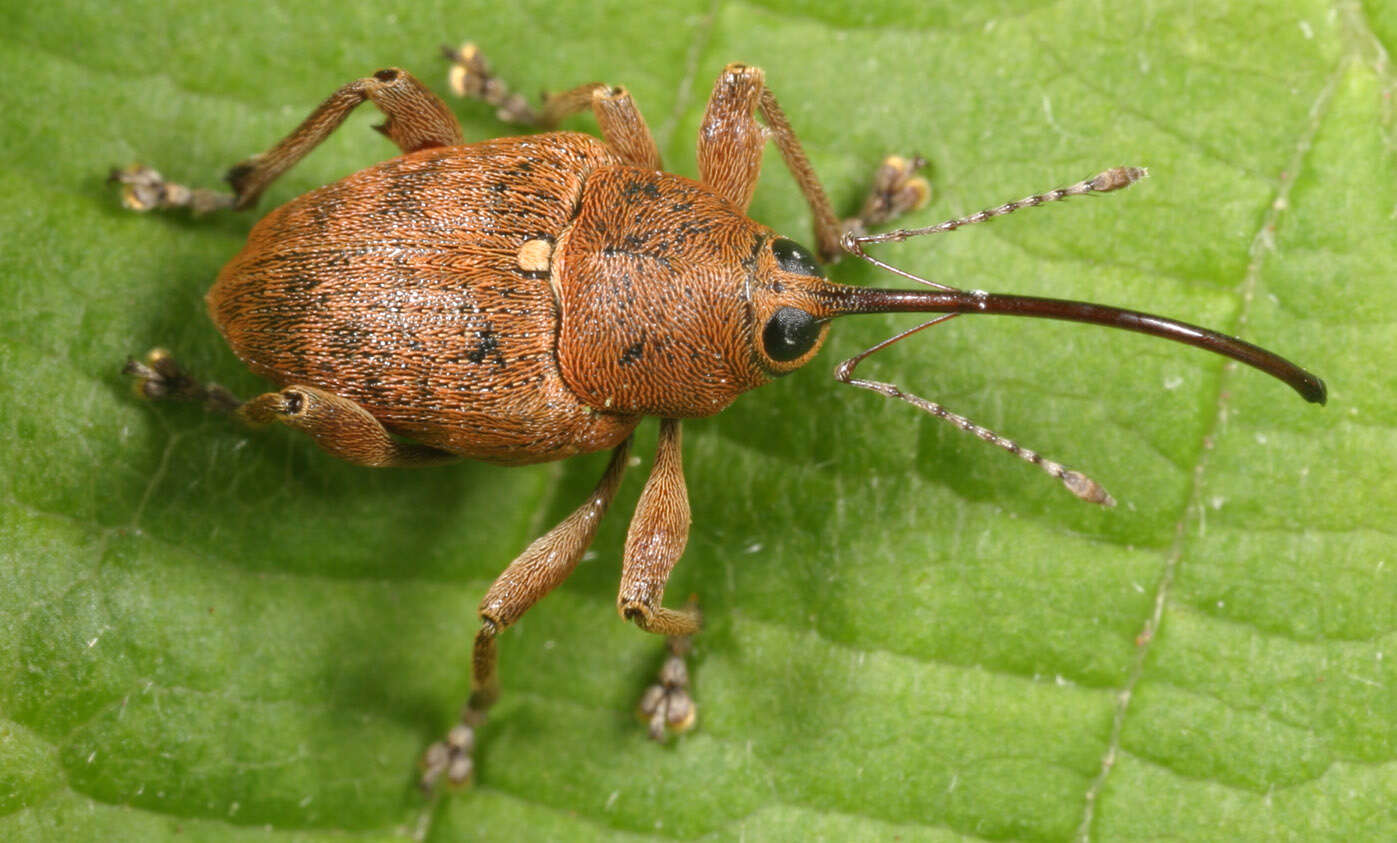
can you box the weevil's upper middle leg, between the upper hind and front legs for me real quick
[441,43,662,169]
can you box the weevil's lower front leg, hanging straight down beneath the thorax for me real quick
[616,418,700,741]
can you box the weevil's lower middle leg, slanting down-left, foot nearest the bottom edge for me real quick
[420,438,630,791]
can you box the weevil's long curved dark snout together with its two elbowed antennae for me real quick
[821,166,1327,506]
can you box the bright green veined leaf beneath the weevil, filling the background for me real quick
[0,0,1397,840]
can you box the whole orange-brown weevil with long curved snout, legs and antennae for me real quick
[113,45,1326,790]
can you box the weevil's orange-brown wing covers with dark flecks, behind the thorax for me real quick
[208,133,640,464]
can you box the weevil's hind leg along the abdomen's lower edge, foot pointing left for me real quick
[126,348,457,467]
